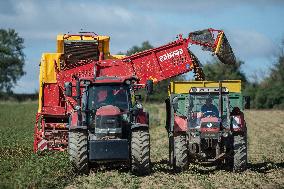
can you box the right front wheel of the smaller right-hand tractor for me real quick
[231,135,247,172]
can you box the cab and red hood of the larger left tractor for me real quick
[86,83,132,139]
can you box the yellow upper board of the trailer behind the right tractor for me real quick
[168,80,241,95]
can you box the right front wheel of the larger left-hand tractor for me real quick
[131,130,150,175]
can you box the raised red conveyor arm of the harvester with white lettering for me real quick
[92,29,235,85]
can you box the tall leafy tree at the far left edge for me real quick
[0,29,25,92]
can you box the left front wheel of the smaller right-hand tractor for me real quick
[174,134,188,172]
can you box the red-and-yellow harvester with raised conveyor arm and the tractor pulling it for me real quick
[34,29,235,175]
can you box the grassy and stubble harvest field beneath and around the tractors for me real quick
[0,102,284,189]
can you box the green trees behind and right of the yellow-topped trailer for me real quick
[203,54,284,109]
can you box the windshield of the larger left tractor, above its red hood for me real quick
[88,85,129,110]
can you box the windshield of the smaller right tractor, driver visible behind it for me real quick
[189,94,228,127]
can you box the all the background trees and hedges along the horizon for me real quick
[0,29,284,109]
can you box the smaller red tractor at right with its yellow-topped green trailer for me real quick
[166,80,247,171]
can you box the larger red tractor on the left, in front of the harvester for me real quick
[65,76,152,175]
